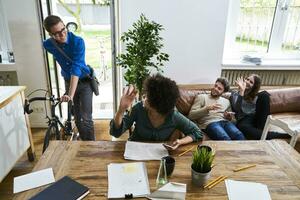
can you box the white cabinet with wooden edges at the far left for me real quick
[0,86,34,182]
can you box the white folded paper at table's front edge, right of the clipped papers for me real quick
[148,182,186,200]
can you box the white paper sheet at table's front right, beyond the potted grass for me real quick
[225,179,271,200]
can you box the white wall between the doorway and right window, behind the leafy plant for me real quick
[119,0,229,84]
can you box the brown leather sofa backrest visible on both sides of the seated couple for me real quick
[176,87,300,115]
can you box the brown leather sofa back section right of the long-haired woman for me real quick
[267,88,300,114]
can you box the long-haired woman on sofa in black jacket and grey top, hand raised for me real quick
[230,74,286,140]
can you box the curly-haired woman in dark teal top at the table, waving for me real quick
[110,74,202,149]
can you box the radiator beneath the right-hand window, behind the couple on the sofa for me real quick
[222,69,300,86]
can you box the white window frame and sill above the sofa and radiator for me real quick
[223,0,300,67]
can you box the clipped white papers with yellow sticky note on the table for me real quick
[107,162,150,199]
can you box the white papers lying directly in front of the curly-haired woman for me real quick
[124,141,169,160]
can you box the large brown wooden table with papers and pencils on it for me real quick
[14,140,300,200]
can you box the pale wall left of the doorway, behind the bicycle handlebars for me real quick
[0,0,47,126]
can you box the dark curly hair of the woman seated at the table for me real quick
[143,74,179,115]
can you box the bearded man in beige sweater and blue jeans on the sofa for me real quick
[189,78,245,140]
